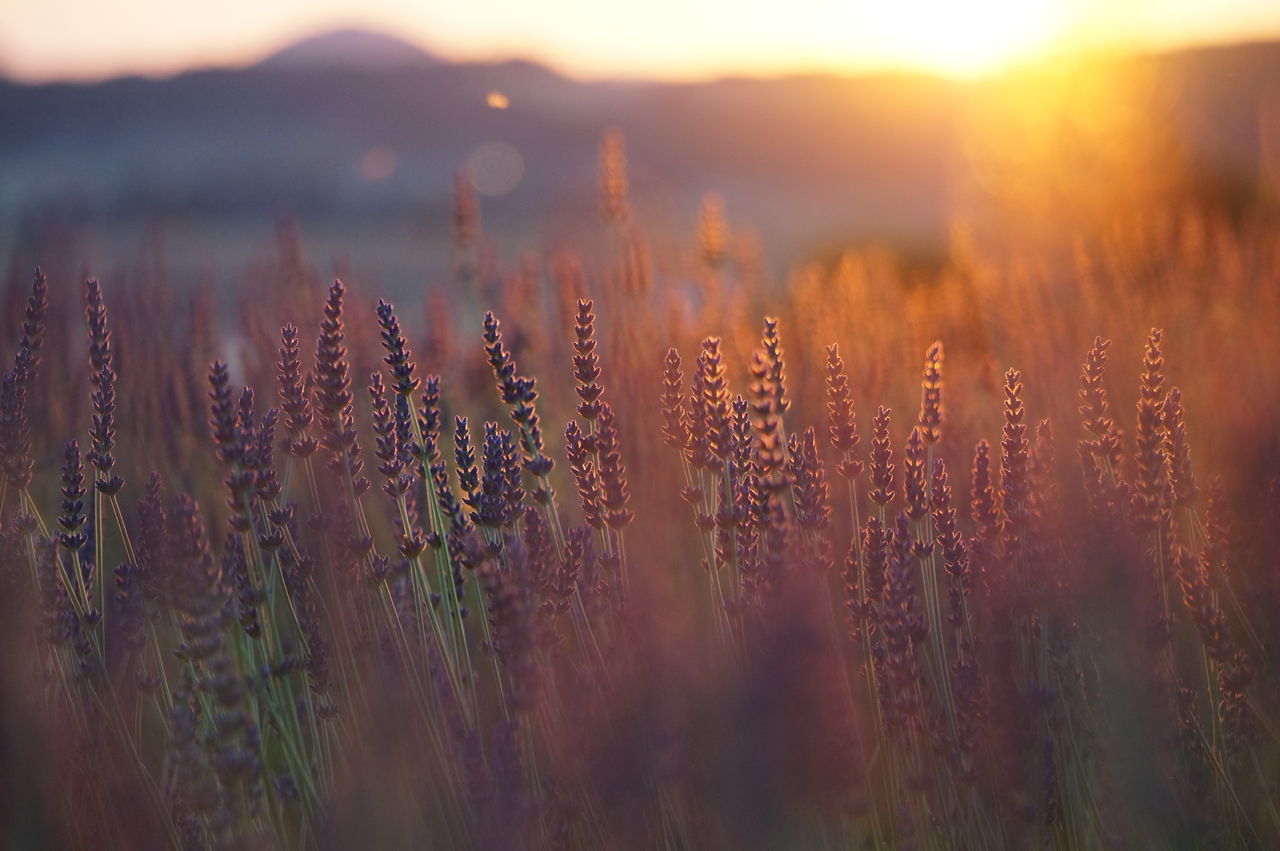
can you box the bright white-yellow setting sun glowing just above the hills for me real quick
[855,0,1068,76]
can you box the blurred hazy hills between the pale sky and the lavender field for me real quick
[0,23,1280,289]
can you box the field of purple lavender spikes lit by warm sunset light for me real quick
[0,136,1280,848]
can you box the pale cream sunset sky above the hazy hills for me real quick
[0,0,1280,79]
